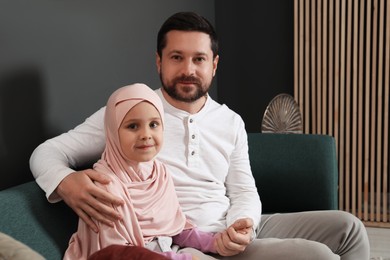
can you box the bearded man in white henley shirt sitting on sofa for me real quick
[30,12,369,260]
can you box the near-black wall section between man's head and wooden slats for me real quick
[215,0,294,132]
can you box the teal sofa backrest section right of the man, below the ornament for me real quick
[248,133,338,213]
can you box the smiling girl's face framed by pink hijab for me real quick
[118,101,163,162]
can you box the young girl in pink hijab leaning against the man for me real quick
[64,84,216,260]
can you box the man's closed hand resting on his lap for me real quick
[215,218,253,256]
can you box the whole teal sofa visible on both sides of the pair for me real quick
[0,133,338,259]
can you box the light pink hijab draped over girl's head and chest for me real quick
[64,84,192,259]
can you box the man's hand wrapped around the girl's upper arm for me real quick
[57,169,124,232]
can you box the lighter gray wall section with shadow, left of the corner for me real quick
[0,0,216,189]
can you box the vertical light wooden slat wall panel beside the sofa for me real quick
[294,0,390,227]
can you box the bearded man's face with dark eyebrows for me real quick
[156,31,218,102]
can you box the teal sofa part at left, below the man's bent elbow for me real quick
[0,181,78,260]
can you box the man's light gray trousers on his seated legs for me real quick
[179,211,370,260]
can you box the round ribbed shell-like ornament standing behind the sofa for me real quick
[261,93,303,134]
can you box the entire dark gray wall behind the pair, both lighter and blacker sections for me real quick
[0,0,293,189]
